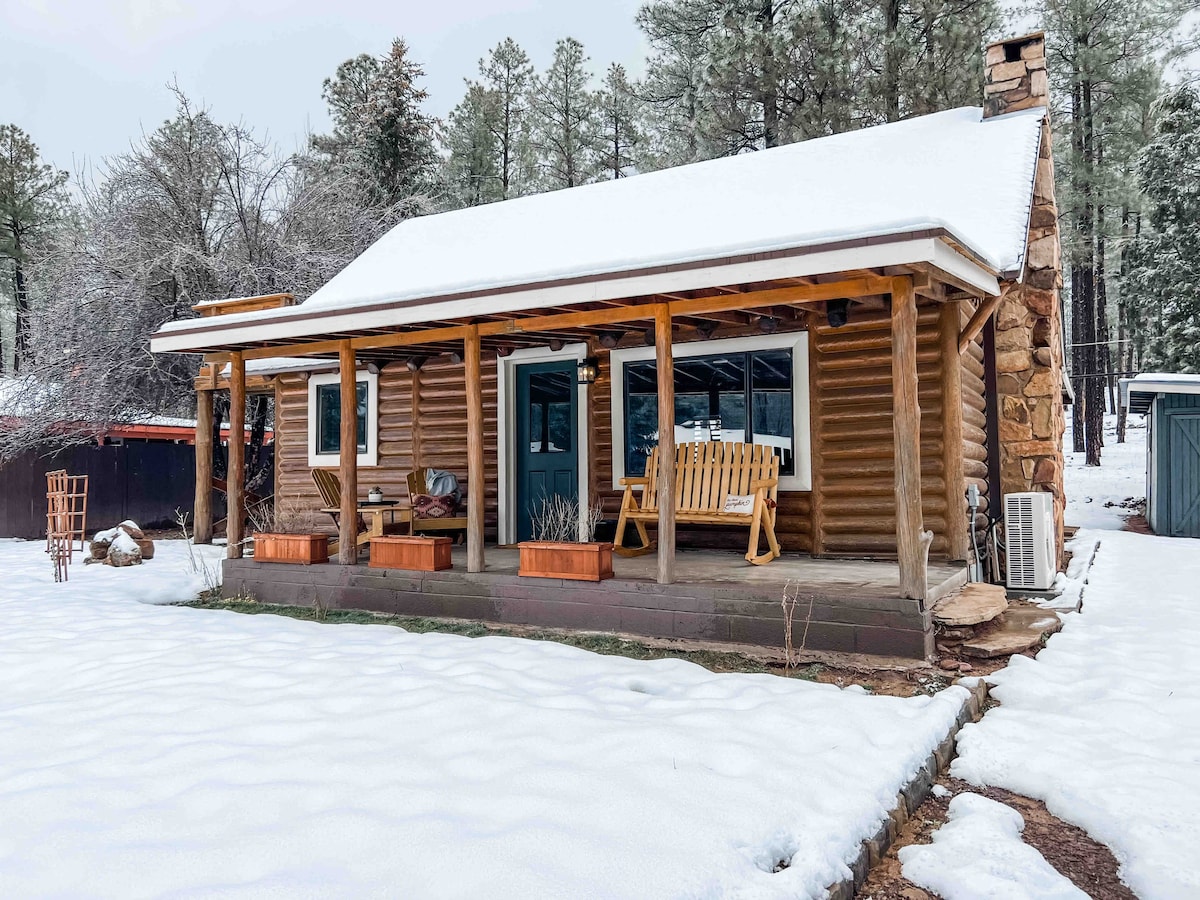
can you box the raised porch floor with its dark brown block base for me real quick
[224,546,966,658]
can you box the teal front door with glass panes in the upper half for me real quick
[514,359,580,541]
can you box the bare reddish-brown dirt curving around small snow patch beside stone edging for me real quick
[858,776,1136,900]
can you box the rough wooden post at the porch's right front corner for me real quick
[892,275,926,600]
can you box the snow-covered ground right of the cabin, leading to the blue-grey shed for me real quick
[952,419,1200,900]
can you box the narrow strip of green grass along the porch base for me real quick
[181,596,824,682]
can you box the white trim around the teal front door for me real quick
[496,343,592,544]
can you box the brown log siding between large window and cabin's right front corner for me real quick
[810,304,948,557]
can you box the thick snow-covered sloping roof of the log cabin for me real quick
[155,107,1044,350]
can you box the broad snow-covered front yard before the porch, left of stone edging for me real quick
[0,542,965,898]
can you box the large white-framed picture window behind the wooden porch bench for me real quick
[613,334,810,490]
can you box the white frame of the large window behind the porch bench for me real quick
[608,331,812,491]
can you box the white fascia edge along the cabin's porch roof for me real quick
[157,229,1000,353]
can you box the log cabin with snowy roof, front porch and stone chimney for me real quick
[152,34,1064,658]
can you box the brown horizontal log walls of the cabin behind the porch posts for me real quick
[276,302,964,557]
